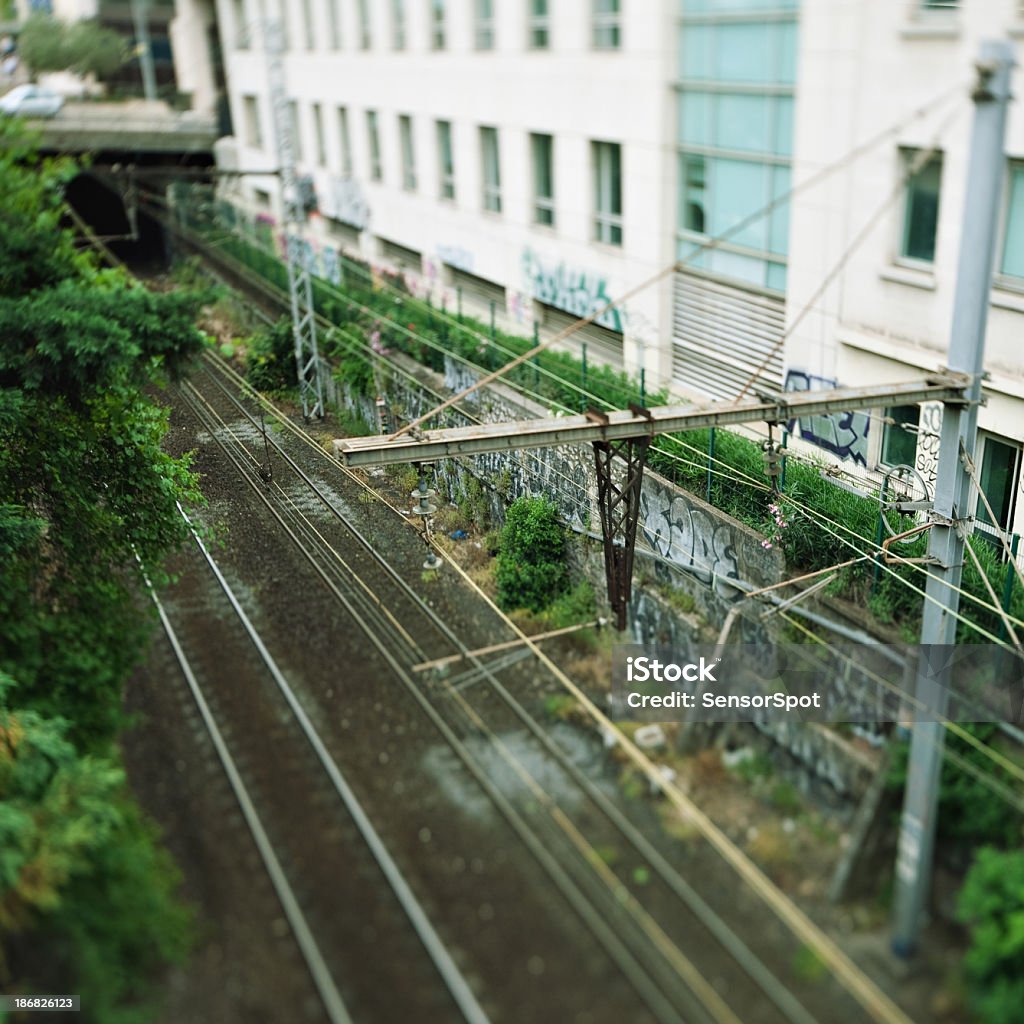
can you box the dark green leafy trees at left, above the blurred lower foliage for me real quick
[0,124,203,745]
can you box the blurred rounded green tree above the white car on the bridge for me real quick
[17,13,130,78]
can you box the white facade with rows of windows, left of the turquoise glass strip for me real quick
[217,0,674,378]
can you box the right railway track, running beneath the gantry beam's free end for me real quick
[163,354,876,1024]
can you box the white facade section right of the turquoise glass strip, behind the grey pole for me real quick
[785,0,1024,544]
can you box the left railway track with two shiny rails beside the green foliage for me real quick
[153,511,489,1024]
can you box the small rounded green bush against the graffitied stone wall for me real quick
[496,498,568,611]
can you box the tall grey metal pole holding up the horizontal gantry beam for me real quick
[892,42,1014,956]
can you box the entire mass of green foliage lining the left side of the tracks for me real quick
[0,123,203,1022]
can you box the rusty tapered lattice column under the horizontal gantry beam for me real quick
[594,437,650,630]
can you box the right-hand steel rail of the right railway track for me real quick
[193,362,814,1024]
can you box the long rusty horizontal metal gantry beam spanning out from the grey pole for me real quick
[334,371,970,466]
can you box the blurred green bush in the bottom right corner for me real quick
[957,847,1024,1024]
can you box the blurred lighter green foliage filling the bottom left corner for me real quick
[0,674,190,1024]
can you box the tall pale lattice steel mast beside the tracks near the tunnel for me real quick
[263,18,324,420]
